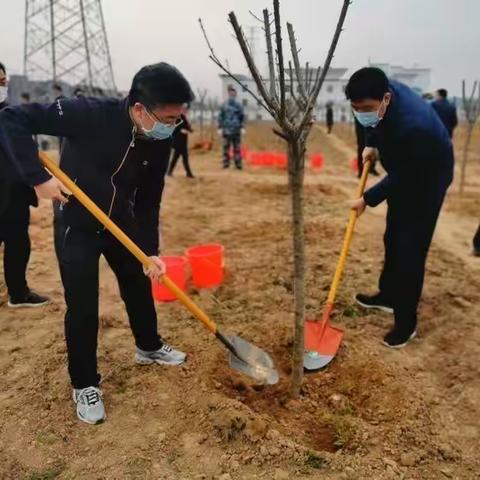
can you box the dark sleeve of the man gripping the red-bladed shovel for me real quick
[363,128,438,207]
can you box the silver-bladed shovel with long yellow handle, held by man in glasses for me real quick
[39,152,278,385]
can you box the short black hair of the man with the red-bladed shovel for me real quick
[345,67,388,102]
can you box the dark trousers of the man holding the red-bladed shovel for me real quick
[379,192,445,333]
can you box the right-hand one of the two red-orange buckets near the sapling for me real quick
[185,243,224,288]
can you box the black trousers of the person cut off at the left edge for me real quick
[0,203,30,301]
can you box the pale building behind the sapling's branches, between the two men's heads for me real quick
[220,68,351,122]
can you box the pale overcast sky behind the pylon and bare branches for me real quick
[0,0,480,95]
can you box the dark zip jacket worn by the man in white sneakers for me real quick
[0,97,171,255]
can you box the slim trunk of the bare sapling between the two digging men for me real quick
[288,141,305,397]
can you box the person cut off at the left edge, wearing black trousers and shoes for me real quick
[0,64,49,308]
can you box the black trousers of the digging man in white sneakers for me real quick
[55,218,162,388]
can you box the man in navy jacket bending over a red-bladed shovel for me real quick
[346,68,453,348]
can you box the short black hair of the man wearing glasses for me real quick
[128,62,195,109]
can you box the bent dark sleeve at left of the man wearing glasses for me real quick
[0,99,103,186]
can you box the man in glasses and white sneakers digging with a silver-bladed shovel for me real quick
[0,63,193,424]
